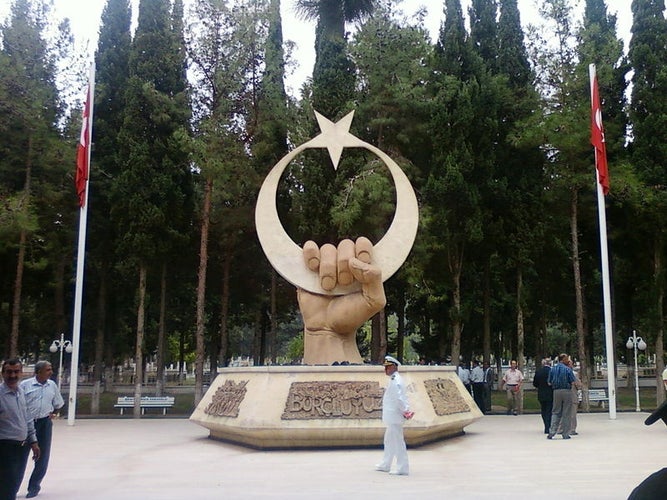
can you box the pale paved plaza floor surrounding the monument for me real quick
[19,413,667,500]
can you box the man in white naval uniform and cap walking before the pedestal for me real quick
[375,356,414,476]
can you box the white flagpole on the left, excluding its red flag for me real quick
[67,62,95,425]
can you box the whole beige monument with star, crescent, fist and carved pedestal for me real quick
[190,112,482,449]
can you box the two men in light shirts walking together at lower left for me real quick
[0,359,65,500]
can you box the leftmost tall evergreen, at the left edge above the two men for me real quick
[0,0,65,357]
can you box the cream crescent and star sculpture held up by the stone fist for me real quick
[255,111,419,295]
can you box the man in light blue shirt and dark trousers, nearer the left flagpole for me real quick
[21,361,65,498]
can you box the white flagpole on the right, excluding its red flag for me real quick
[588,64,616,420]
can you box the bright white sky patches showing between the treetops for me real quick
[0,0,632,95]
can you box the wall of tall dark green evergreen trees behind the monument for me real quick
[0,0,667,400]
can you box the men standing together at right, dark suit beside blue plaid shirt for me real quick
[533,353,582,439]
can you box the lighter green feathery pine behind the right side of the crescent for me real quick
[352,1,432,361]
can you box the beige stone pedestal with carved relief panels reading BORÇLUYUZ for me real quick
[190,365,482,449]
